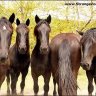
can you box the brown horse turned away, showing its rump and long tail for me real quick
[50,33,81,96]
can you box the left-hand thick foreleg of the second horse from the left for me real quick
[11,72,20,94]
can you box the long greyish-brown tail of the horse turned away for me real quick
[58,39,77,95]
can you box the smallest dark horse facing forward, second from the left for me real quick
[7,18,30,94]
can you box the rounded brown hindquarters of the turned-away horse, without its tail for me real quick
[50,33,81,77]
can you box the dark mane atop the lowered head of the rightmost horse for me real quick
[81,28,96,43]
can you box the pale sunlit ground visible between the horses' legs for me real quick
[0,68,95,95]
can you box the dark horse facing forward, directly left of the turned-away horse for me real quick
[31,15,51,95]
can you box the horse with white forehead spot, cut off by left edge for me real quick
[0,13,15,88]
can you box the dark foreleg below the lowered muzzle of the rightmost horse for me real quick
[86,71,94,95]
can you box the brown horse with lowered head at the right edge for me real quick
[79,28,96,95]
